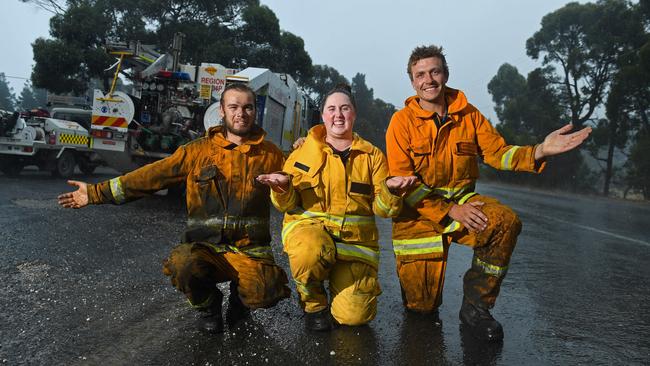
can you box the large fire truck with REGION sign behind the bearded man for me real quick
[91,33,318,173]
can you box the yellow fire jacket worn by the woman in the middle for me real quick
[271,125,402,267]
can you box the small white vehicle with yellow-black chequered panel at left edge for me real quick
[0,108,102,178]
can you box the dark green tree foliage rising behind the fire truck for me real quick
[32,0,313,94]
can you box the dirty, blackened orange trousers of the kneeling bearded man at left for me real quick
[163,243,291,310]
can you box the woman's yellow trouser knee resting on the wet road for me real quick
[330,262,381,325]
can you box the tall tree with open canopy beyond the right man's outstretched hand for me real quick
[526,0,645,195]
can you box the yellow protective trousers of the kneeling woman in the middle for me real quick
[284,221,381,325]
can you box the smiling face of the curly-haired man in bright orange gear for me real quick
[411,57,449,105]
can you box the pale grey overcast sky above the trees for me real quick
[0,0,584,119]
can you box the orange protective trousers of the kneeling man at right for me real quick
[396,195,521,312]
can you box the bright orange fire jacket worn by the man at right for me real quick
[386,87,545,259]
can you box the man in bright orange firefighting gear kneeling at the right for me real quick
[386,46,591,340]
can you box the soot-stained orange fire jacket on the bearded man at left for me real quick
[88,126,284,258]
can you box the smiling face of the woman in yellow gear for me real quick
[322,93,357,140]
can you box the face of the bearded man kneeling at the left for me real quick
[220,89,255,137]
